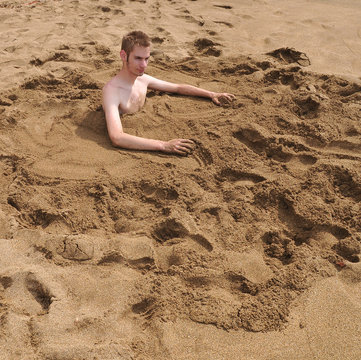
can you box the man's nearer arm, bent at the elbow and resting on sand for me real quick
[103,85,194,155]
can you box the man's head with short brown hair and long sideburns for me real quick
[120,31,151,76]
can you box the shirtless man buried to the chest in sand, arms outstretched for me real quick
[103,31,235,155]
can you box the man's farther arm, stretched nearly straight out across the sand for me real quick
[148,76,235,105]
